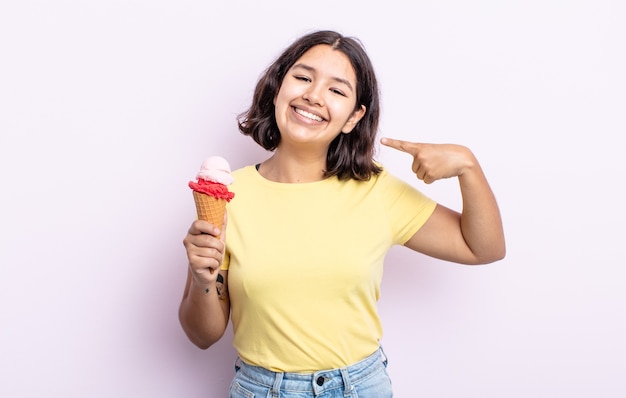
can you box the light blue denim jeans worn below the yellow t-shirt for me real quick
[229,348,393,398]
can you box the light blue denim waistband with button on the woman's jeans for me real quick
[235,347,387,396]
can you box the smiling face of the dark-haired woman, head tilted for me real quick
[274,44,365,150]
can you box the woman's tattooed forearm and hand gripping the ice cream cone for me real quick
[178,220,230,349]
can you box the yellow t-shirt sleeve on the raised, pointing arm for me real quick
[379,170,437,245]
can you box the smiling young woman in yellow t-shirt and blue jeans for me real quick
[180,31,505,398]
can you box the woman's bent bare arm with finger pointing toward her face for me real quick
[381,138,506,264]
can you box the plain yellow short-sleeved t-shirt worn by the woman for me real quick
[222,166,436,373]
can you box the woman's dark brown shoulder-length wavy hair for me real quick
[237,30,381,180]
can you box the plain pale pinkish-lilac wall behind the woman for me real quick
[0,0,626,398]
